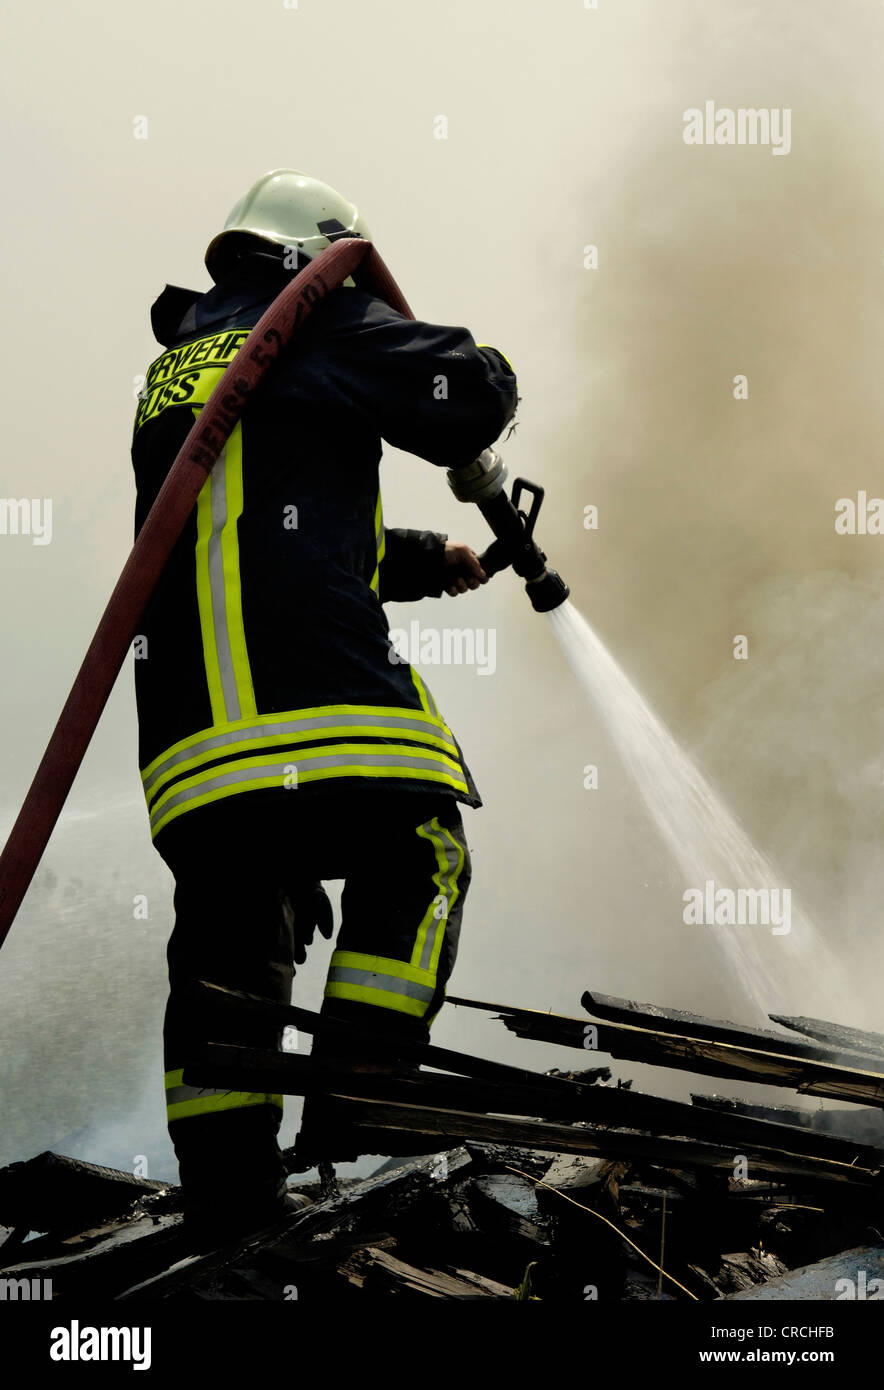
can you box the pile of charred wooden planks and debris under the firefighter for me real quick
[0,986,884,1302]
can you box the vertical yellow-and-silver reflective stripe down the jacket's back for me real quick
[193,411,257,721]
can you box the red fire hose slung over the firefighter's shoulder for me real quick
[0,238,414,945]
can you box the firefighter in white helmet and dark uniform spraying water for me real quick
[132,170,516,1229]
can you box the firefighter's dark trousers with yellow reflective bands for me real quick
[156,788,471,1209]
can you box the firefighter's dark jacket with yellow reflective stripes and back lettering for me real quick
[132,272,516,837]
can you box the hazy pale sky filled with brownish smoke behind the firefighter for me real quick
[0,0,884,1173]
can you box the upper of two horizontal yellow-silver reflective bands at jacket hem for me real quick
[142,705,457,801]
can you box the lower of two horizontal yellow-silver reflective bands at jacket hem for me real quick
[150,744,468,835]
